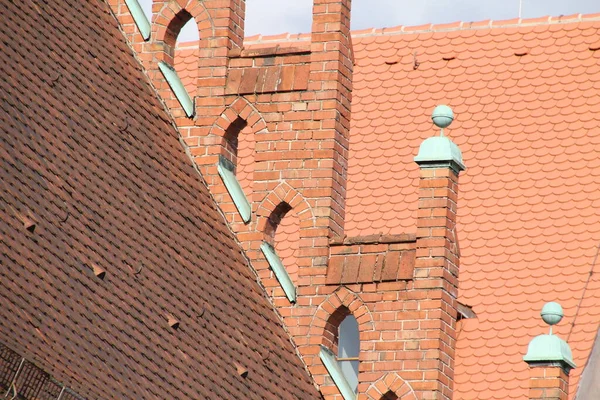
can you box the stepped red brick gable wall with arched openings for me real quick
[110,0,458,399]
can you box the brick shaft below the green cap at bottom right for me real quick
[529,364,569,400]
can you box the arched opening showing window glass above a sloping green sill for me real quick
[319,307,360,400]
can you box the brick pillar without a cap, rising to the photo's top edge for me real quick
[307,0,352,236]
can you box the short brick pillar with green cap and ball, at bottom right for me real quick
[523,302,575,400]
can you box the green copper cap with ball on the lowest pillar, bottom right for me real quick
[523,302,575,374]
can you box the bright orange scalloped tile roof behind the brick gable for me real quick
[346,15,600,399]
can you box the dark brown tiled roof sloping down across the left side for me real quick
[0,0,320,399]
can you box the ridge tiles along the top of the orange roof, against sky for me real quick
[177,13,600,49]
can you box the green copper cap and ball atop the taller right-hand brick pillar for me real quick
[415,105,466,173]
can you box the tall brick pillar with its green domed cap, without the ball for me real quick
[413,122,464,399]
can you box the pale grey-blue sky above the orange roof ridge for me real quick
[139,0,600,42]
